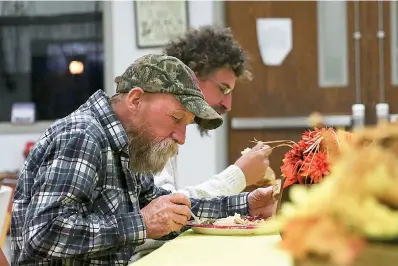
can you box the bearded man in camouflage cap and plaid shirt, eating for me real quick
[11,55,272,265]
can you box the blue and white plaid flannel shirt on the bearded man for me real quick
[11,90,247,266]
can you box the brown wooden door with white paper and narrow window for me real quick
[225,1,380,184]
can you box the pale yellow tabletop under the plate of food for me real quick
[129,229,294,266]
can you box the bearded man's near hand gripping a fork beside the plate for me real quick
[141,193,191,239]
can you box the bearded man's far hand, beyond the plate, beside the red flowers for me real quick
[248,186,276,219]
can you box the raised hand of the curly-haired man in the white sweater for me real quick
[235,141,272,186]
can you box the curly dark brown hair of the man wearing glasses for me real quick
[163,26,252,80]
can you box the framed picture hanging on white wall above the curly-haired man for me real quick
[134,0,189,48]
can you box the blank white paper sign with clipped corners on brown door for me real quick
[256,18,293,66]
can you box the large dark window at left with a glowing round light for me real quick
[0,1,104,122]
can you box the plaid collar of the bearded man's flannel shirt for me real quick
[87,90,128,153]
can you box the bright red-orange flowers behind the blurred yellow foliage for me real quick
[281,128,339,188]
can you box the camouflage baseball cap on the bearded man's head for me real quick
[115,54,223,129]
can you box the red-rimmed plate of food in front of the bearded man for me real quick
[188,214,279,236]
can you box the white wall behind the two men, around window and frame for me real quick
[0,1,227,186]
